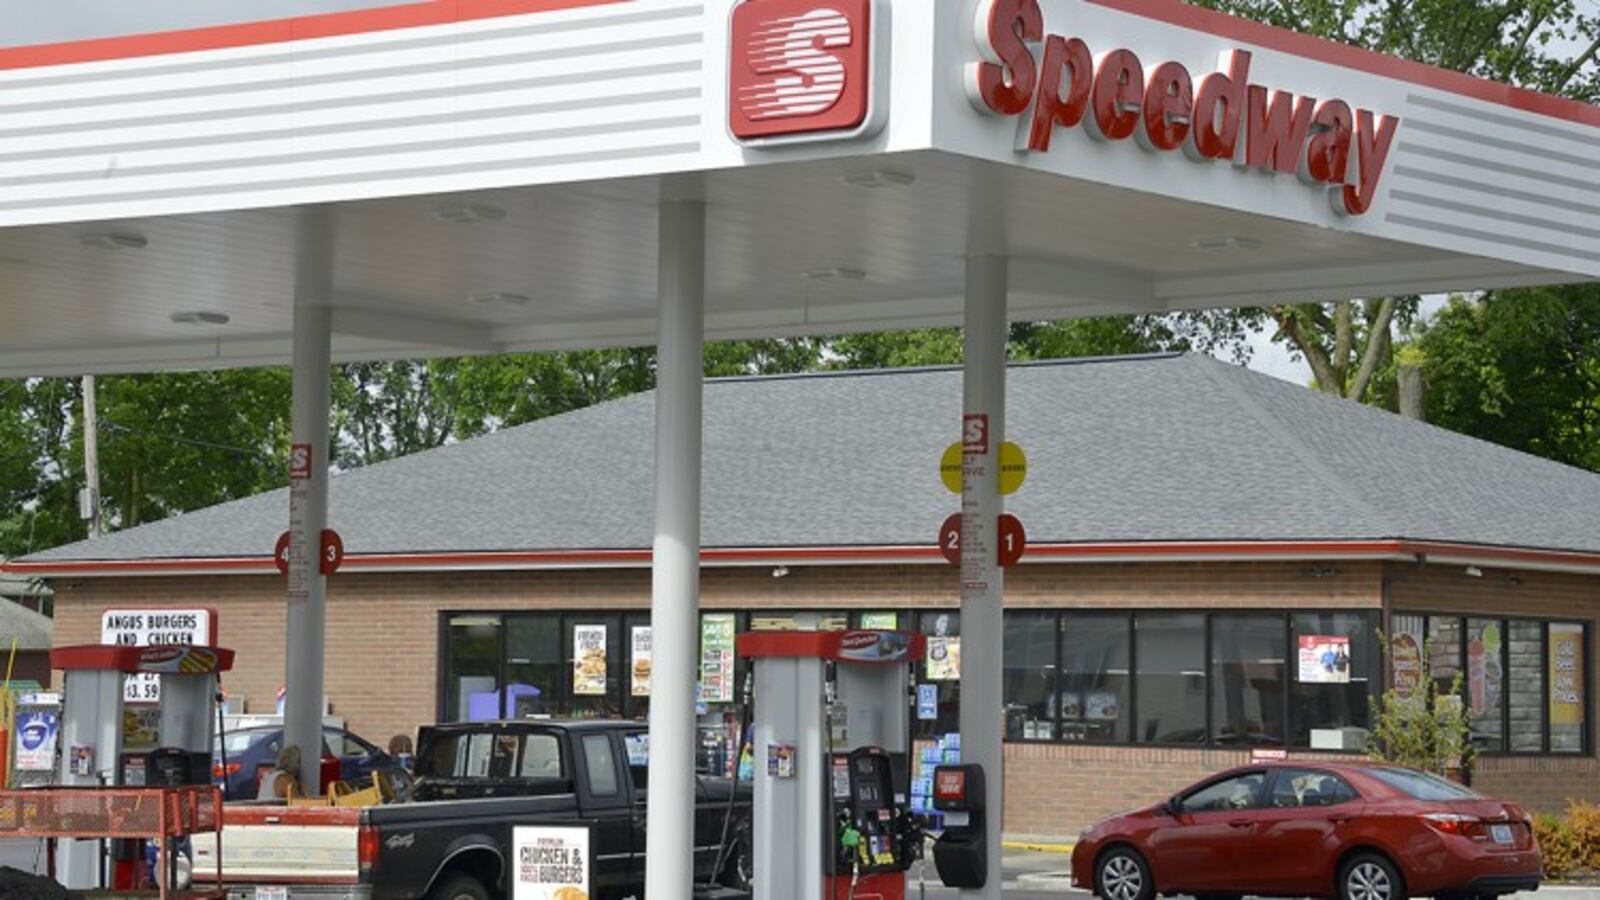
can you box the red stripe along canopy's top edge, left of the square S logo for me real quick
[0,0,630,69]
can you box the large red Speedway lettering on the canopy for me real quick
[966,0,1400,216]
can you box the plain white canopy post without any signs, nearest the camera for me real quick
[645,200,706,900]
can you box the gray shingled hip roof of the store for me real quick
[29,356,1600,560]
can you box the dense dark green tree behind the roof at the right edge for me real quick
[1414,283,1600,471]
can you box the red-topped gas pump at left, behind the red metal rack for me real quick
[50,644,234,890]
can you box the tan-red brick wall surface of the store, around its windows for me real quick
[43,562,1600,836]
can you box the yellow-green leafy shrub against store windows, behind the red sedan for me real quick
[1366,631,1477,775]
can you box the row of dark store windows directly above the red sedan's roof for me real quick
[1005,610,1378,751]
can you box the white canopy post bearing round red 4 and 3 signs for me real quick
[283,208,333,794]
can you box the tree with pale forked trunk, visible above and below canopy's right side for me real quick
[1195,0,1600,402]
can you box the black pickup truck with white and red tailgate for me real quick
[194,721,750,900]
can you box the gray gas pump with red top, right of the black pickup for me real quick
[739,631,926,900]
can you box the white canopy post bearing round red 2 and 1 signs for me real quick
[962,256,1006,900]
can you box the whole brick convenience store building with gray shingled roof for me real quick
[11,356,1600,834]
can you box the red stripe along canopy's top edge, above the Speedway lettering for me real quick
[1088,0,1600,128]
